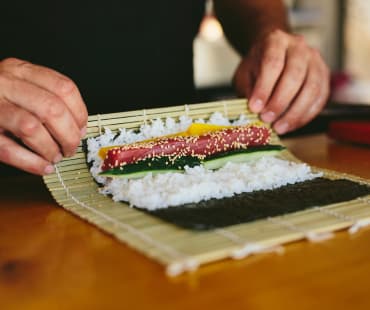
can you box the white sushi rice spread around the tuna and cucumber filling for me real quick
[88,113,321,210]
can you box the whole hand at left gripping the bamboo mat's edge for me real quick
[0,58,88,175]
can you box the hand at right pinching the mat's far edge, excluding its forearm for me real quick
[234,30,329,134]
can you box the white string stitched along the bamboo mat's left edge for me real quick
[54,165,199,276]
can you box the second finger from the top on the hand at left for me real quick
[0,74,81,156]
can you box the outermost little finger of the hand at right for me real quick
[273,60,329,134]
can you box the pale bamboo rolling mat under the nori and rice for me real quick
[44,99,370,276]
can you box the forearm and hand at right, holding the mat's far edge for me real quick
[214,0,329,134]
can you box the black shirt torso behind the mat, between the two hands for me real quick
[0,0,204,114]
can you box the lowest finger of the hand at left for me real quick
[0,134,54,175]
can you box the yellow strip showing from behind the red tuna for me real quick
[98,123,254,159]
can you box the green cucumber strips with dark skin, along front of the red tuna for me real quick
[100,145,285,179]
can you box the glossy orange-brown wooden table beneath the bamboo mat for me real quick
[0,135,370,310]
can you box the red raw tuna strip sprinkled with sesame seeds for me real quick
[102,125,270,171]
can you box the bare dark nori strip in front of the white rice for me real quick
[143,178,370,230]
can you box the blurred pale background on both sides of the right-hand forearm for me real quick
[194,0,370,135]
